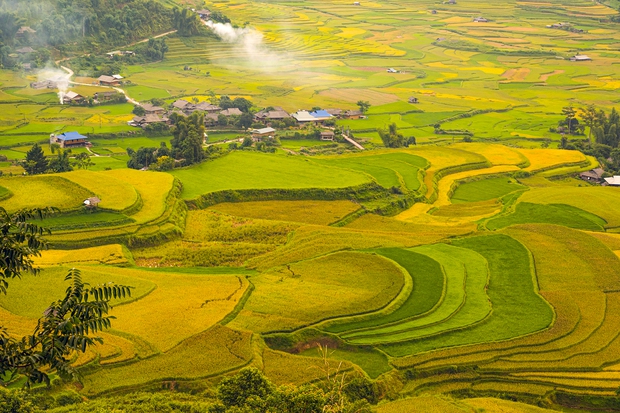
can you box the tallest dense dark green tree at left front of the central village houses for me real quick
[170,112,205,165]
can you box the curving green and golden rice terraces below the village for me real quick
[0,140,620,409]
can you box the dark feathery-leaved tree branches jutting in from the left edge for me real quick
[0,208,131,384]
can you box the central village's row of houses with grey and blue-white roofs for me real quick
[129,99,364,130]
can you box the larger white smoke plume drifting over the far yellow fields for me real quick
[205,20,283,68]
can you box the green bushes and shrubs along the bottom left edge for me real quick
[0,368,376,413]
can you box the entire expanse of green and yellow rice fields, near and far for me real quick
[0,0,620,406]
